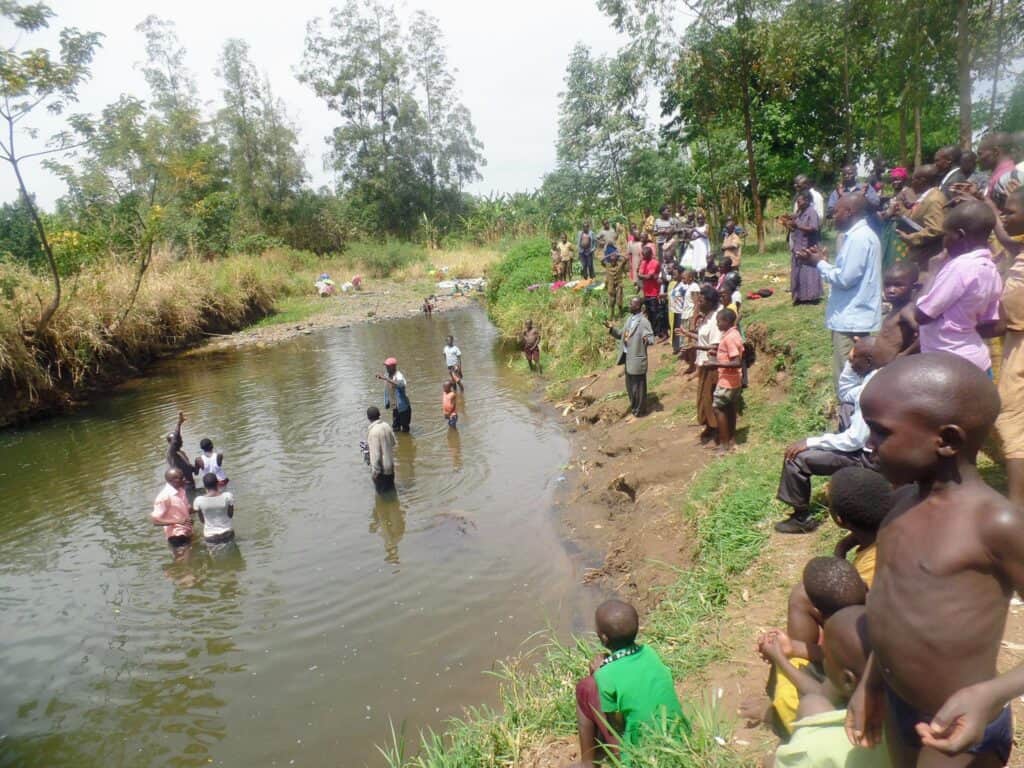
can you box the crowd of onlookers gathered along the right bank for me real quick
[552,133,1024,768]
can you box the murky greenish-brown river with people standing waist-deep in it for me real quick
[0,309,598,768]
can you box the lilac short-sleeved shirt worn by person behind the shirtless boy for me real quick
[918,248,1002,371]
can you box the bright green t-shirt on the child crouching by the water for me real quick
[594,645,685,746]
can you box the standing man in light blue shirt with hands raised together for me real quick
[800,195,882,390]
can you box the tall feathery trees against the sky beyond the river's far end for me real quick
[299,0,482,237]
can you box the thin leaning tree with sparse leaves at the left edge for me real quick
[0,0,100,338]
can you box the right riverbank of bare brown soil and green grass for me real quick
[387,241,830,768]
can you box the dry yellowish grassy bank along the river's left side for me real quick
[0,243,497,426]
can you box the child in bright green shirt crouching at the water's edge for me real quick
[577,600,689,768]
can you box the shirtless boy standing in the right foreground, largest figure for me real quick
[847,352,1024,767]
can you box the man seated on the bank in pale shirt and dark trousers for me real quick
[775,337,877,534]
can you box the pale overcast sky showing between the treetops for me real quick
[0,0,643,207]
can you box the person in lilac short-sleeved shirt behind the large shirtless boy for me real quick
[915,201,1002,375]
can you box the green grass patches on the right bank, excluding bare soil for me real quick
[386,241,830,768]
